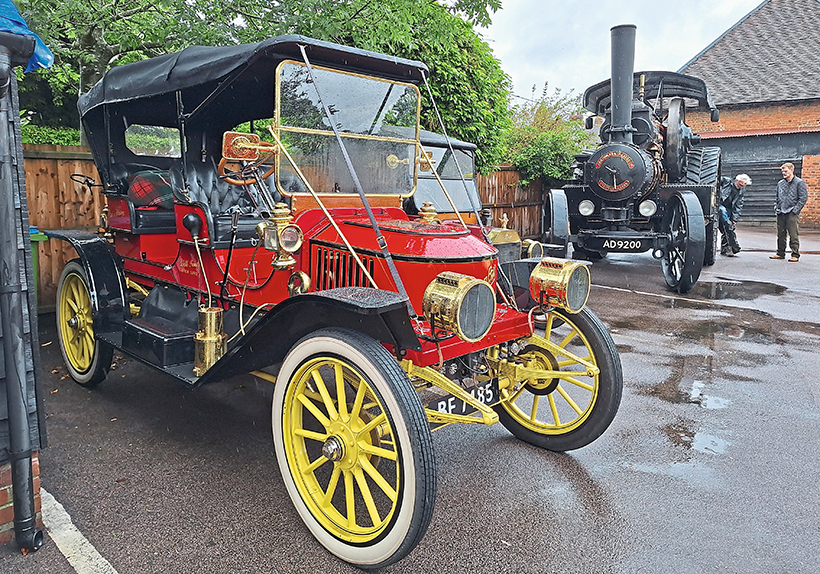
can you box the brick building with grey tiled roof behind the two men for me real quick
[679,0,820,227]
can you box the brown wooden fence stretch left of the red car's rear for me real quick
[23,145,105,310]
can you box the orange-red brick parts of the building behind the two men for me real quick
[686,102,820,228]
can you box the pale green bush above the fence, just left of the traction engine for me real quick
[505,85,594,186]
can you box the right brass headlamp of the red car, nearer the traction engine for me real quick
[530,257,590,313]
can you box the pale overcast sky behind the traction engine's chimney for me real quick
[479,0,762,97]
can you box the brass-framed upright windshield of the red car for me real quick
[274,62,420,196]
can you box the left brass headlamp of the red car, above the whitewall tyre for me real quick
[422,271,495,343]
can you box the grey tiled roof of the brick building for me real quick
[679,0,820,106]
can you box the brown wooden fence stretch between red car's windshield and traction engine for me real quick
[476,167,544,239]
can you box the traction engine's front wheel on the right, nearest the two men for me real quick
[661,191,706,293]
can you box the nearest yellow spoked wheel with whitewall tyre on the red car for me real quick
[272,329,436,568]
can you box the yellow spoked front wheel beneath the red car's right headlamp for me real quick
[496,308,623,451]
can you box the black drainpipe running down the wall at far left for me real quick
[0,34,43,551]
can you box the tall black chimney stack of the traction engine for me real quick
[609,24,637,143]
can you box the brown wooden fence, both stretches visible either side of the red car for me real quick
[23,145,543,311]
